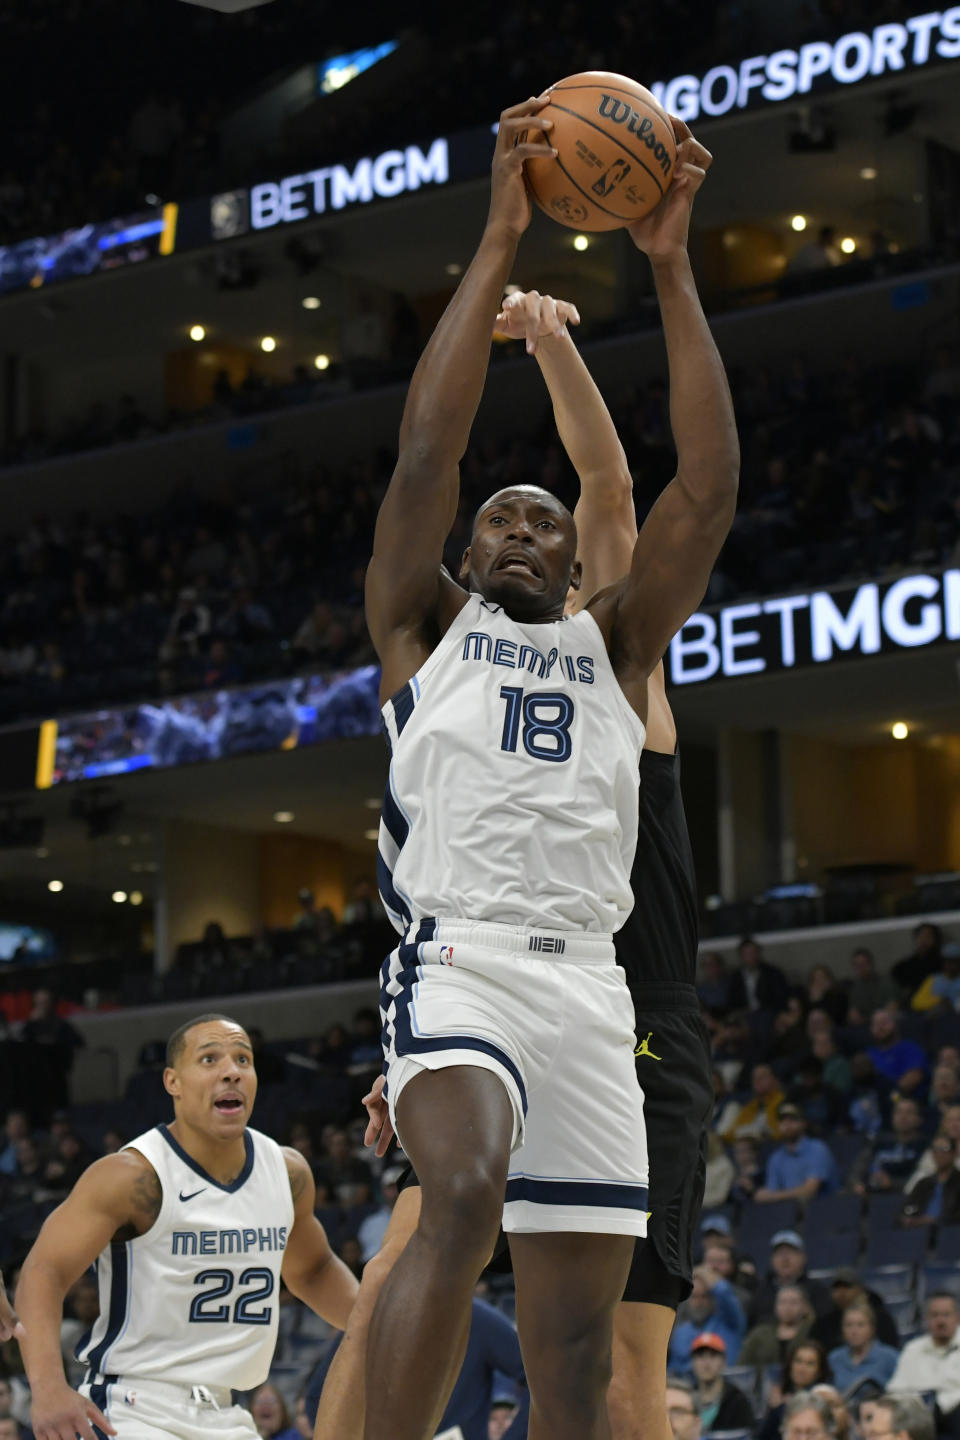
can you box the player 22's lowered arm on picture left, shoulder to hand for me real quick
[16,1151,163,1440]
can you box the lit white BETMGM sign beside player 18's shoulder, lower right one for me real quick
[669,570,960,685]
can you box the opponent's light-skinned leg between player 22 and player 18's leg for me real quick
[314,1185,420,1440]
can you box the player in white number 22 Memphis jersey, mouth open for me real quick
[17,1015,357,1440]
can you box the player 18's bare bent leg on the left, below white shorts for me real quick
[364,1066,517,1440]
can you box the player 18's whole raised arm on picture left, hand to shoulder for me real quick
[366,98,550,694]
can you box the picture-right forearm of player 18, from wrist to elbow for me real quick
[653,251,740,507]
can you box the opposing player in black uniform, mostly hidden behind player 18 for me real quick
[315,149,714,1440]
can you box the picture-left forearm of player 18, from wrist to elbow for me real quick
[400,225,517,471]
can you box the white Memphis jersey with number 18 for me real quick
[377,595,645,933]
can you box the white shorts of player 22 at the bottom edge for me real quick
[78,1375,259,1440]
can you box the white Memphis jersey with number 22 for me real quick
[76,1125,294,1390]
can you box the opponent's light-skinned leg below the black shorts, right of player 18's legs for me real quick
[607,1300,676,1440]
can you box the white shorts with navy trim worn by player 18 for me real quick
[380,920,648,1236]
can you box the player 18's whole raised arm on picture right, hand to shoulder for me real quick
[604,120,740,674]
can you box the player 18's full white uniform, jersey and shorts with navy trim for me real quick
[377,595,648,1236]
